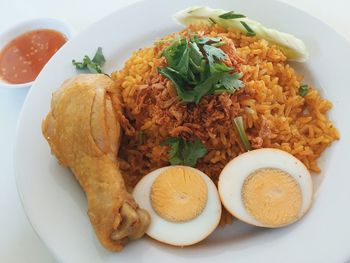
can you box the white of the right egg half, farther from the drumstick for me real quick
[218,148,313,228]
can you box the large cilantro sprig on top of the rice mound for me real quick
[158,34,244,103]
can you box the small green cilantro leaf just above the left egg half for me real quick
[160,137,207,167]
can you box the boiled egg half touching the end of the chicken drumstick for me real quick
[133,166,221,246]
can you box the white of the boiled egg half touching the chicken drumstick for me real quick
[133,166,221,246]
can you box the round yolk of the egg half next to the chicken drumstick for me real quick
[150,167,208,222]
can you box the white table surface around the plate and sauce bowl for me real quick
[0,0,350,263]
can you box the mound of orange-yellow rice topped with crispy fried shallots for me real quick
[112,25,339,224]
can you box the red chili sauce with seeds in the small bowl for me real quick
[0,29,67,84]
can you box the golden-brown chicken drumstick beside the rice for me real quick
[42,74,150,251]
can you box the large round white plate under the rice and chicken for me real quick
[15,0,350,263]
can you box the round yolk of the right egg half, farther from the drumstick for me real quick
[241,168,302,226]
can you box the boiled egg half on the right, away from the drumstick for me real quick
[218,148,313,228]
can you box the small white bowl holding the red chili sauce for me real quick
[0,18,73,88]
